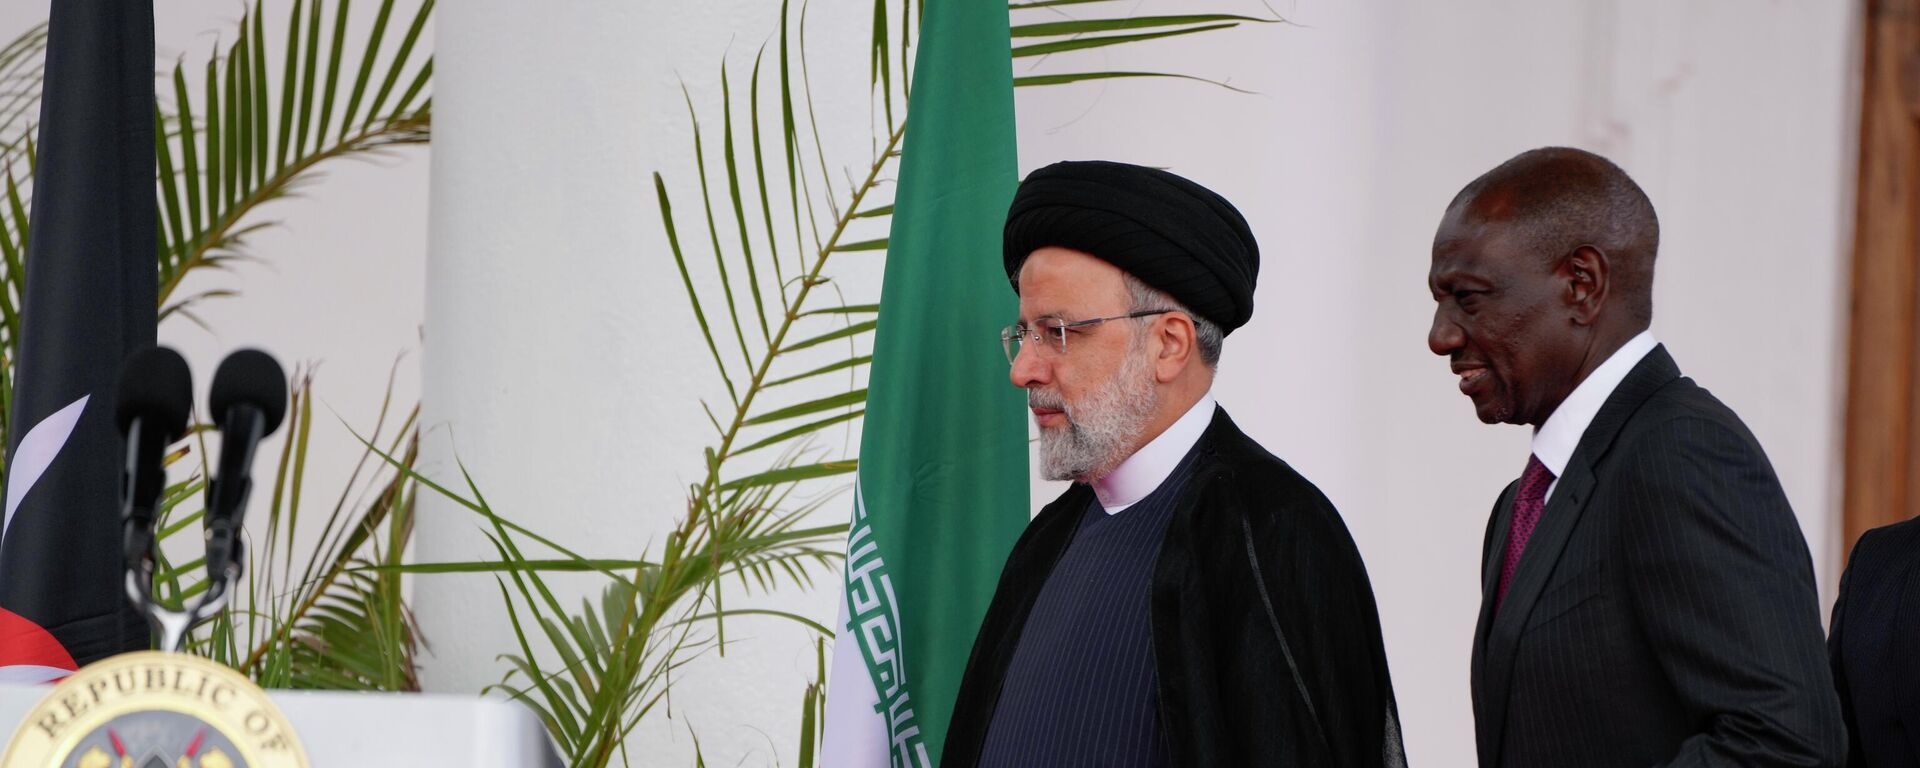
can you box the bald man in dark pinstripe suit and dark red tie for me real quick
[1427,148,1845,768]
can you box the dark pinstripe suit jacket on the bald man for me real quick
[1473,348,1845,768]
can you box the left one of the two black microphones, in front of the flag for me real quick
[113,348,194,570]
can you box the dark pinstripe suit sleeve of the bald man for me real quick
[1617,419,1845,766]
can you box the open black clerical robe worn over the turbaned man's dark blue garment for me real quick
[941,411,1405,768]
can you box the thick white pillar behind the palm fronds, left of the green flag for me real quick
[415,0,879,764]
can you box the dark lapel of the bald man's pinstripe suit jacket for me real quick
[1475,346,1680,764]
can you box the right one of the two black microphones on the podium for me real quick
[207,349,286,580]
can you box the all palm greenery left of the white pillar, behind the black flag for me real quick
[0,0,434,691]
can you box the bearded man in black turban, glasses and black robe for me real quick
[941,161,1405,768]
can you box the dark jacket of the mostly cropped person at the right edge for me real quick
[1828,518,1920,768]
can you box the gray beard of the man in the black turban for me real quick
[1027,344,1160,482]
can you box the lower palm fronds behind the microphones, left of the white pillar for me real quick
[127,372,420,691]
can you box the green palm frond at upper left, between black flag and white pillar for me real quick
[156,0,434,309]
